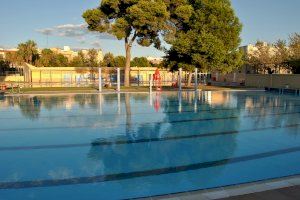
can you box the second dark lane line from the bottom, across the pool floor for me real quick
[0,124,300,152]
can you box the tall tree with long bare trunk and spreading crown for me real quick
[83,0,169,86]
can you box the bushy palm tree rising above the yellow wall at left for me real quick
[18,40,39,64]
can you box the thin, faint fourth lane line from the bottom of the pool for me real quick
[0,105,300,120]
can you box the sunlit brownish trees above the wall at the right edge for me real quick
[245,33,300,74]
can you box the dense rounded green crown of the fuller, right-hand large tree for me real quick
[166,0,242,85]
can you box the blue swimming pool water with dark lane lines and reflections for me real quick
[0,92,300,200]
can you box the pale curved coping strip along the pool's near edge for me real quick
[137,175,300,200]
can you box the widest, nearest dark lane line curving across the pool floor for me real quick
[0,146,300,190]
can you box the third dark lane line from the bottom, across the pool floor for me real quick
[0,112,300,134]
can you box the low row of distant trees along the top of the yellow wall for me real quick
[0,40,162,71]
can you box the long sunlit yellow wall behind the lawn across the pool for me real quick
[0,68,211,92]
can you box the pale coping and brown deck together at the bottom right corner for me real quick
[143,175,300,200]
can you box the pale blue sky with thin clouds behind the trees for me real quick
[0,0,300,56]
